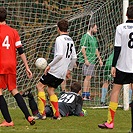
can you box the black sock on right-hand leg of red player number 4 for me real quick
[14,93,30,120]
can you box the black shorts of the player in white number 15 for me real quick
[40,73,63,88]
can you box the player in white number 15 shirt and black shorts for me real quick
[36,19,77,119]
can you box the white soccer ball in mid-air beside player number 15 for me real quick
[35,58,47,70]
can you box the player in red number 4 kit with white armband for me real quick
[0,7,35,127]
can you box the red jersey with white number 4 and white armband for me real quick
[0,25,22,74]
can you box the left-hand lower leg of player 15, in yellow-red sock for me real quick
[36,82,46,119]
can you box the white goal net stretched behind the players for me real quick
[0,0,128,107]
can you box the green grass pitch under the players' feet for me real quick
[0,108,131,133]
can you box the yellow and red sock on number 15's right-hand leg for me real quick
[50,94,60,117]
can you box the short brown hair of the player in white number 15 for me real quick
[57,19,68,32]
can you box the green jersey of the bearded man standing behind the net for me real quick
[79,33,98,64]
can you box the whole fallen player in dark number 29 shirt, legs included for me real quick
[22,82,85,119]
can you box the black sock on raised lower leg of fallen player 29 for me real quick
[28,93,39,115]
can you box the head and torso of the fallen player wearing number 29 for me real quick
[58,82,84,116]
